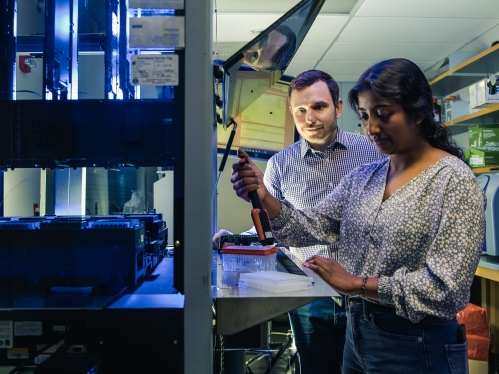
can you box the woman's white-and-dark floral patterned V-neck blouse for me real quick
[272,156,485,322]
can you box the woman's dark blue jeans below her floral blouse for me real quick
[343,298,468,374]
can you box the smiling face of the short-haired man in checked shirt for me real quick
[289,81,343,152]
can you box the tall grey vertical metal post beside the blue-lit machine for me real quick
[183,0,216,374]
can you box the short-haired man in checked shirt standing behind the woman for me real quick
[214,70,384,374]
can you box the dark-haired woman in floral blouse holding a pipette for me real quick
[231,59,485,374]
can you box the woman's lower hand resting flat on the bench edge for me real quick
[303,256,362,295]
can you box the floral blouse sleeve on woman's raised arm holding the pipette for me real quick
[272,175,351,247]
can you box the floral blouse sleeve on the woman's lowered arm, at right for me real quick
[378,177,485,322]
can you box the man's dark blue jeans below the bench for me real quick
[289,297,346,374]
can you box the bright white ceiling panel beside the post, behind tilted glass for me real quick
[213,14,282,42]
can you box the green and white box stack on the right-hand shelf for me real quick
[464,124,499,168]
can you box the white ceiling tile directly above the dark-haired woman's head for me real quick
[323,42,463,62]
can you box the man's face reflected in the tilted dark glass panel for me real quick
[243,30,287,70]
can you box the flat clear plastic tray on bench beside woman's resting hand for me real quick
[239,271,313,292]
